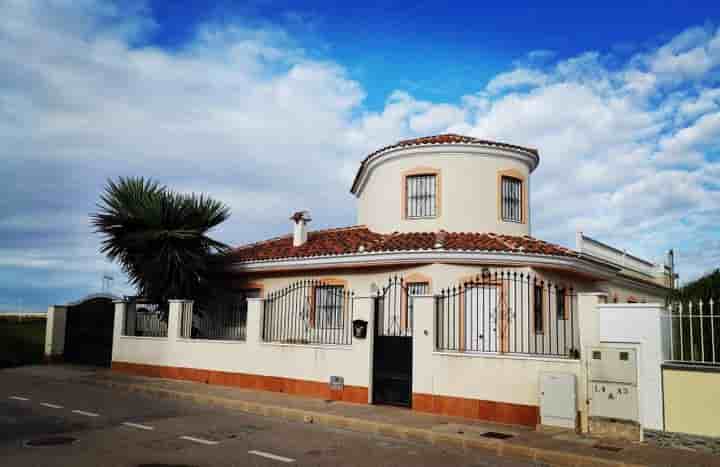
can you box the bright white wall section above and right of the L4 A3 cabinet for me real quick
[598,303,666,430]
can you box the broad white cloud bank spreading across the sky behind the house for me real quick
[0,0,720,310]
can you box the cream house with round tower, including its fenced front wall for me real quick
[113,134,674,429]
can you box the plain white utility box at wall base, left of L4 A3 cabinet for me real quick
[540,373,577,428]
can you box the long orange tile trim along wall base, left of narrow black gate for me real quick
[112,362,368,404]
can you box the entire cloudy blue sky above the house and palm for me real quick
[0,0,720,309]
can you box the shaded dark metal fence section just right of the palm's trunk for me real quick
[180,294,247,341]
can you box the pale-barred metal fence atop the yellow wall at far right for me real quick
[664,299,720,365]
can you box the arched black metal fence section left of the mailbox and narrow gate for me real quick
[262,280,355,345]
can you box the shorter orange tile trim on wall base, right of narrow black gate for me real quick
[413,393,540,427]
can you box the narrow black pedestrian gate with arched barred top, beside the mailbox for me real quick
[373,277,413,407]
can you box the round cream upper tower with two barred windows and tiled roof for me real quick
[351,134,540,235]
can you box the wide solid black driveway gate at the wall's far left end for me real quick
[63,297,115,367]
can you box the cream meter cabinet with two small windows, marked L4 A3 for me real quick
[590,347,639,422]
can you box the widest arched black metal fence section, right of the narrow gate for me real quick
[435,271,580,358]
